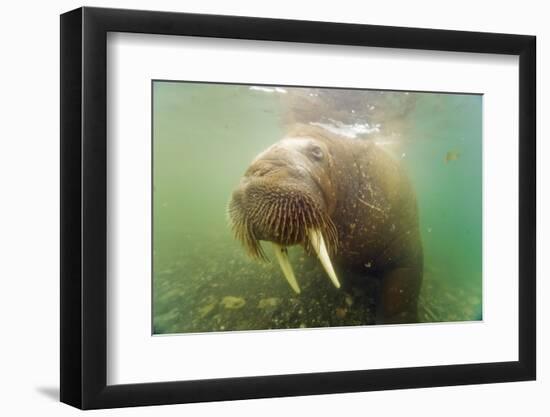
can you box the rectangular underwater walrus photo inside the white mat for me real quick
[152,80,483,335]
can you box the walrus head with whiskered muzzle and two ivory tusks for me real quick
[228,129,340,293]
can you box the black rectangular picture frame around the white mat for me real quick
[60,7,536,409]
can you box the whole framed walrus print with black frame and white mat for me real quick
[61,7,536,409]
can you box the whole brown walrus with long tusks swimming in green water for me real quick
[228,125,423,323]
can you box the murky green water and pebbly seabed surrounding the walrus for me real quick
[153,81,482,334]
